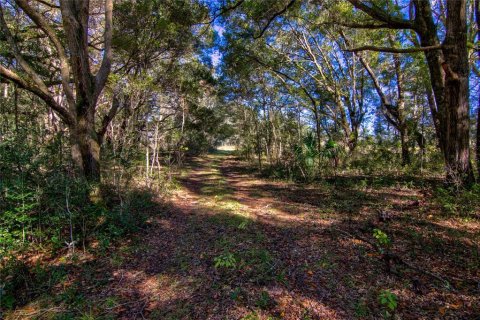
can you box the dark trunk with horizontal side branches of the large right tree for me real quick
[348,0,474,186]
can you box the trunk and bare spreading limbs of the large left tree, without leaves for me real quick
[0,0,113,182]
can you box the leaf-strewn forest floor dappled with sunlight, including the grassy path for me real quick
[7,152,480,319]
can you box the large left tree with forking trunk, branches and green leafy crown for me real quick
[0,0,208,184]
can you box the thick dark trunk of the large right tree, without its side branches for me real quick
[415,0,475,186]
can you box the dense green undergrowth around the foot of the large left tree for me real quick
[0,132,153,309]
